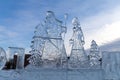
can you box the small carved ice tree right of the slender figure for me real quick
[89,40,101,68]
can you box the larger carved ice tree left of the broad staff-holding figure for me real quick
[28,24,46,66]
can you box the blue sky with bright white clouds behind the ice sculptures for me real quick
[0,0,120,53]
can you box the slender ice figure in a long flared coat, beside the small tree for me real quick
[69,18,87,68]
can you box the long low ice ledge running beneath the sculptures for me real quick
[0,68,104,80]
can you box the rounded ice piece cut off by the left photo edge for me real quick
[0,47,7,69]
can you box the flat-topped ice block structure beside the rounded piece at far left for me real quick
[9,47,25,69]
